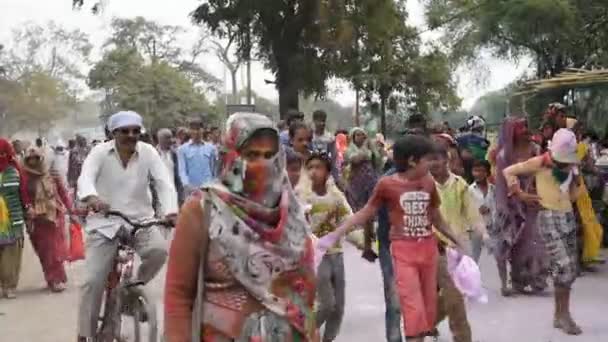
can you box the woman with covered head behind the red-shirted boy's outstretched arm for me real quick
[344,127,382,253]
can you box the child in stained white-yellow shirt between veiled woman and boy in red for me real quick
[298,153,352,342]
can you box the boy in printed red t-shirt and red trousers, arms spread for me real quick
[336,135,460,342]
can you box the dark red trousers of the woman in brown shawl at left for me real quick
[30,215,68,286]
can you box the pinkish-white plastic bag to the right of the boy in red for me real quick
[447,248,488,304]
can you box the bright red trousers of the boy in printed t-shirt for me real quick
[391,237,439,337]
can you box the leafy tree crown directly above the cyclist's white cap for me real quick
[88,17,219,130]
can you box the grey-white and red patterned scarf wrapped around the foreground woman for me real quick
[204,113,316,342]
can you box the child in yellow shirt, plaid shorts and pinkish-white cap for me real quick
[503,128,582,335]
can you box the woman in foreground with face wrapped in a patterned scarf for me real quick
[165,113,317,342]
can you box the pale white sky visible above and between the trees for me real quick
[0,0,528,109]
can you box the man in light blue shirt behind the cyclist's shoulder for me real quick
[177,120,218,196]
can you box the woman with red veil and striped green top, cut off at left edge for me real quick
[0,139,30,299]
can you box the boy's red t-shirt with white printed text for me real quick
[370,174,441,240]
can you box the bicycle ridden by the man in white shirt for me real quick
[96,211,171,342]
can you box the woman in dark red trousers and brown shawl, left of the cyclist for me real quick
[23,148,71,292]
